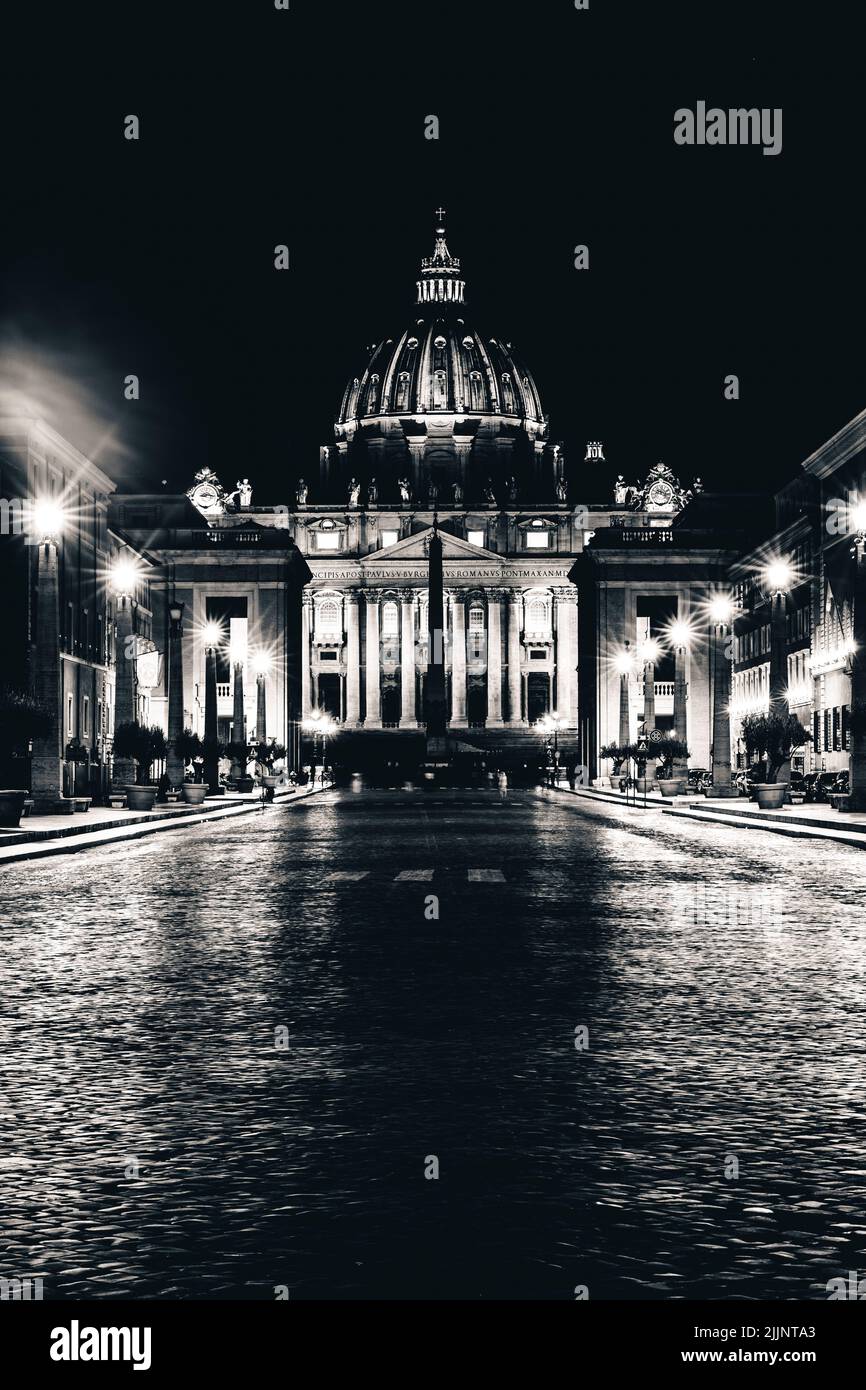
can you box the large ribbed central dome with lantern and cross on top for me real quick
[336,210,544,439]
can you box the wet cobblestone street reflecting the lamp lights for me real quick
[0,791,866,1300]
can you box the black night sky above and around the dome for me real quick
[0,0,866,502]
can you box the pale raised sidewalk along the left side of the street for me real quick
[0,787,331,867]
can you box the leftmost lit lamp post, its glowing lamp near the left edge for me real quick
[31,498,65,810]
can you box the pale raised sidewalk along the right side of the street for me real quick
[556,785,866,849]
